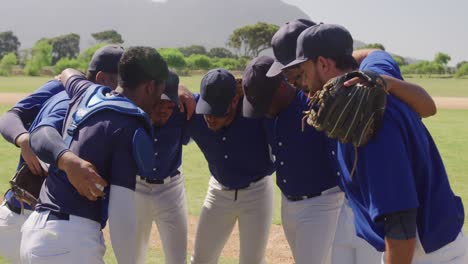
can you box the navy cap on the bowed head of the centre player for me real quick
[195,69,236,117]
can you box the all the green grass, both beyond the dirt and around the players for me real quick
[0,75,468,263]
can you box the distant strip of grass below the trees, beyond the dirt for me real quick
[0,75,468,97]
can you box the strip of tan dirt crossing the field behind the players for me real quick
[0,93,468,109]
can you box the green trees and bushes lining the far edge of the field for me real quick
[0,22,468,77]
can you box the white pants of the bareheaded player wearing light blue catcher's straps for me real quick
[21,211,106,264]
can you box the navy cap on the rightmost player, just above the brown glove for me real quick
[283,24,353,69]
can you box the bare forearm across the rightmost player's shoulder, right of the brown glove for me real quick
[382,76,437,117]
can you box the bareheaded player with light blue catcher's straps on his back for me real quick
[21,47,168,263]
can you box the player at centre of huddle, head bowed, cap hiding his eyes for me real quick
[187,69,274,264]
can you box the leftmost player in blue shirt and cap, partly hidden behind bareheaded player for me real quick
[0,45,123,263]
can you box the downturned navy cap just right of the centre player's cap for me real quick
[242,56,284,118]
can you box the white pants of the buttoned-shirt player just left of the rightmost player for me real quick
[281,187,344,264]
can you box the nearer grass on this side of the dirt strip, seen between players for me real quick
[0,106,468,263]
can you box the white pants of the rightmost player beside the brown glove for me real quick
[381,231,468,264]
